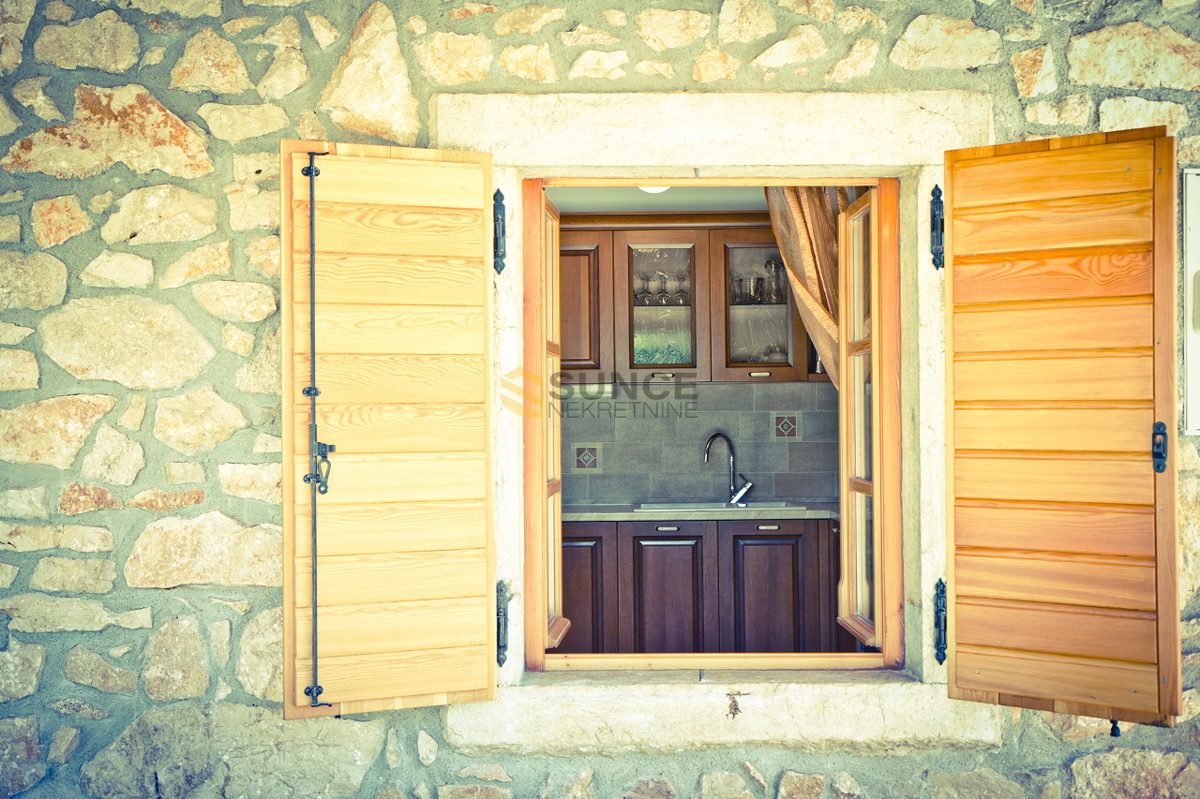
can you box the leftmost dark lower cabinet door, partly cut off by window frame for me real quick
[556,522,617,655]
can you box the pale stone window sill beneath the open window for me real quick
[443,669,1008,756]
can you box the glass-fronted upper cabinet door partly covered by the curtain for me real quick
[710,228,809,382]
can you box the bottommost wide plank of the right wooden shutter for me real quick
[955,644,1158,711]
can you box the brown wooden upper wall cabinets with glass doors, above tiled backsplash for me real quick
[558,214,823,384]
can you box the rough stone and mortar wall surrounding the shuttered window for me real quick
[0,0,1200,799]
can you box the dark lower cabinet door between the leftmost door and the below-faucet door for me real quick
[617,522,718,653]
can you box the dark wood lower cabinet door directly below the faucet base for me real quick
[719,521,828,653]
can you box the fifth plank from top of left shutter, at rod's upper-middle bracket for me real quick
[292,355,487,405]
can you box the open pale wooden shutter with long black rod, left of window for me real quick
[281,142,496,717]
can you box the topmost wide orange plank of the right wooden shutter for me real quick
[953,140,1154,208]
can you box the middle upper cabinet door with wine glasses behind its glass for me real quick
[613,230,709,382]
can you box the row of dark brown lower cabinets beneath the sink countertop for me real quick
[557,519,853,654]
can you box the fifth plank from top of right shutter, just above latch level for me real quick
[954,349,1154,402]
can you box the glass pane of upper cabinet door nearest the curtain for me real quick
[725,247,793,364]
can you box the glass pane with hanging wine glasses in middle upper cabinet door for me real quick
[629,245,696,366]
